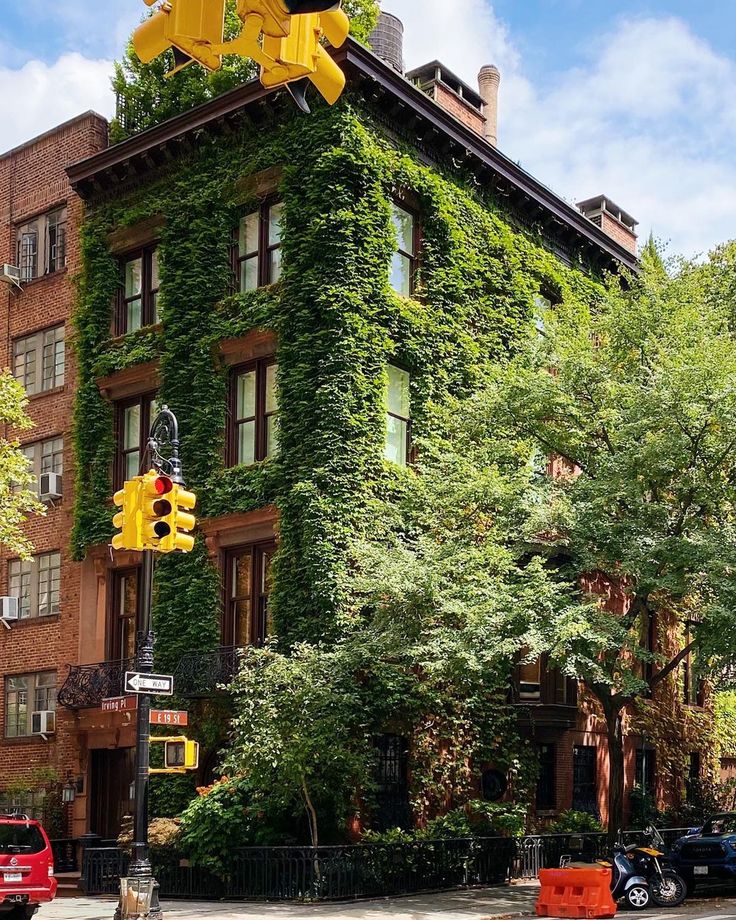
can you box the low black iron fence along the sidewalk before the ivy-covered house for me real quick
[82,837,514,901]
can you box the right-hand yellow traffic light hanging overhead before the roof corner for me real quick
[261,7,350,111]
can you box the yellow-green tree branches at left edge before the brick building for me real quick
[0,371,46,559]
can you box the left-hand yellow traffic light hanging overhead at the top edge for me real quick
[133,0,225,76]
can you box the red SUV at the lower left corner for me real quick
[0,815,57,920]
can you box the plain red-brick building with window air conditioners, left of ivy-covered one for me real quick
[0,112,107,824]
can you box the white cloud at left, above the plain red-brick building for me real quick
[0,53,114,152]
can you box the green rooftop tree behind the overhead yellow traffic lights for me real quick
[110,0,378,143]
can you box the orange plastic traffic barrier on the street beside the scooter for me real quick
[537,866,616,920]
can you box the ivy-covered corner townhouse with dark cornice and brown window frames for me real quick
[8,16,698,837]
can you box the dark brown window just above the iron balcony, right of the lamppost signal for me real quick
[222,543,274,648]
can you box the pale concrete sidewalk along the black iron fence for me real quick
[36,882,539,920]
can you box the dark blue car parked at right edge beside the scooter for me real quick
[670,812,736,893]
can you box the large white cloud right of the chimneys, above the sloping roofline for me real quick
[384,0,736,255]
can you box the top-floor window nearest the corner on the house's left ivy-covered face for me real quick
[236,202,284,291]
